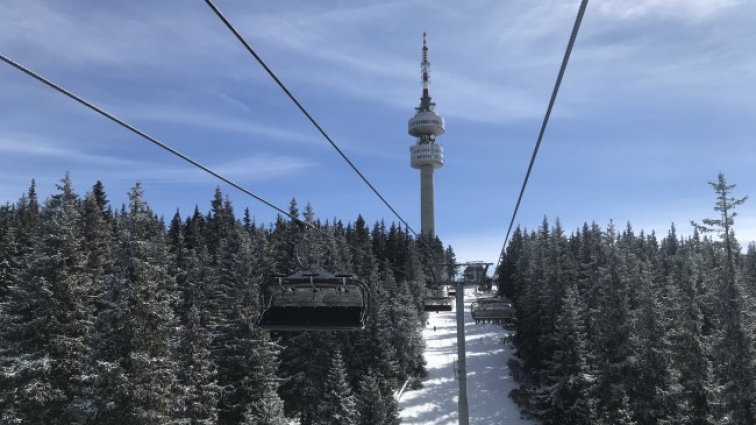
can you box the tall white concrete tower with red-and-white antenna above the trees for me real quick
[408,33,444,237]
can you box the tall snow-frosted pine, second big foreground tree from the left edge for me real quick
[98,183,177,425]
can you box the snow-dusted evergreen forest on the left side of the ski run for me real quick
[0,176,453,425]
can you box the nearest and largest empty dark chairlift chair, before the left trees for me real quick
[258,270,369,331]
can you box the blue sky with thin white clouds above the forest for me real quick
[0,0,756,262]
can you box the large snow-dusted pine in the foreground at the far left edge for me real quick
[0,174,94,424]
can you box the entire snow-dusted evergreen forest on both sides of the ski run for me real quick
[5,175,756,425]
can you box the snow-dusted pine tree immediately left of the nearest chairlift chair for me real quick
[208,204,281,425]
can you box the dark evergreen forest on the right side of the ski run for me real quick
[499,175,756,425]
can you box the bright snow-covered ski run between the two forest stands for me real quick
[399,287,536,425]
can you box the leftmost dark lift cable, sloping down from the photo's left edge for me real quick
[0,54,420,282]
